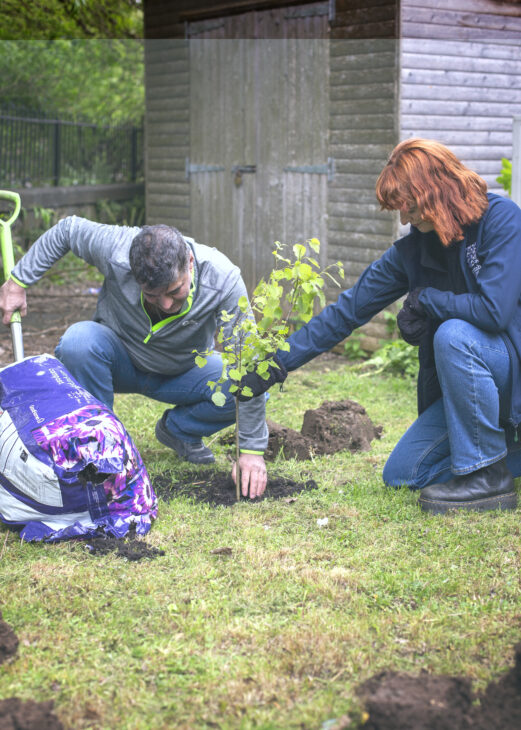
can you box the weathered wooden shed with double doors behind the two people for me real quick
[144,0,521,337]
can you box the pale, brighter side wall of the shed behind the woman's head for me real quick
[400,0,521,192]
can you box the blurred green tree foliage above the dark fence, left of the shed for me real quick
[0,0,144,124]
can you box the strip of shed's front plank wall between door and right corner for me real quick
[328,0,398,347]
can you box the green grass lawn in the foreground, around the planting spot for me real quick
[0,361,521,730]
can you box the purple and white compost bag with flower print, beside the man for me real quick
[0,355,157,541]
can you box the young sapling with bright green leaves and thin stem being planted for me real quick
[195,238,344,500]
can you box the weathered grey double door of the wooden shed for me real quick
[187,2,332,291]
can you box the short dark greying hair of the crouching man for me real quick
[129,224,190,290]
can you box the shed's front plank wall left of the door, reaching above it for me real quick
[144,0,330,234]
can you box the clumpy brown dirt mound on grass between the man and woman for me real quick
[265,400,383,460]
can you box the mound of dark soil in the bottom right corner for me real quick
[358,644,521,730]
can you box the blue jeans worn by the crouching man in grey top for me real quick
[56,322,235,443]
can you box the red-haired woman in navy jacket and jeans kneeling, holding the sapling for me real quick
[242,139,521,513]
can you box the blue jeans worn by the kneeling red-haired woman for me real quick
[383,319,521,489]
